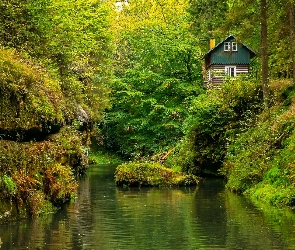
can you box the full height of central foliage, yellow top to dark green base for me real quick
[102,0,203,159]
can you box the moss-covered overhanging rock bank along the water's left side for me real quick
[0,48,102,222]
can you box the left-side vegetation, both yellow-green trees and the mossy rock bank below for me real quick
[0,0,113,220]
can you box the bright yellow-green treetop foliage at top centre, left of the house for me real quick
[114,0,200,77]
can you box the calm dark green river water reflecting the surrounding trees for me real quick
[0,166,295,250]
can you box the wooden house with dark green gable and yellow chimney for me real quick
[204,35,256,87]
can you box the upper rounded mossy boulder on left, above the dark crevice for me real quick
[0,48,65,140]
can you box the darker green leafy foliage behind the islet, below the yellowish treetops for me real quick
[102,70,204,158]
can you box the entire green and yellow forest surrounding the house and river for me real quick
[0,0,295,220]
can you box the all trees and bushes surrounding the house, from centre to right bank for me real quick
[108,0,295,205]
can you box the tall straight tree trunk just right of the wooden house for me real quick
[260,0,269,107]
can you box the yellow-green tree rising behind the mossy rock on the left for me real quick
[30,0,114,121]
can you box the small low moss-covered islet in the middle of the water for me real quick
[115,163,199,186]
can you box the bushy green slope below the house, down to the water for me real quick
[168,80,295,207]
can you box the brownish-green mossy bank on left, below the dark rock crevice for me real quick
[0,127,88,220]
